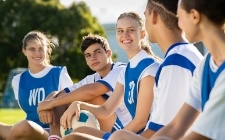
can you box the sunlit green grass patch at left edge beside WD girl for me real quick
[0,108,26,124]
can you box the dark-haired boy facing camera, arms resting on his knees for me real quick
[38,34,127,139]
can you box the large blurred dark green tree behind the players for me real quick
[0,0,106,91]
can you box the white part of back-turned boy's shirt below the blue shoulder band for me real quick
[149,65,192,127]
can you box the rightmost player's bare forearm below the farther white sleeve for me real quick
[151,103,199,139]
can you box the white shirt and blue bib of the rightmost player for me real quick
[186,53,225,140]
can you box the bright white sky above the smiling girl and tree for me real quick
[60,0,147,23]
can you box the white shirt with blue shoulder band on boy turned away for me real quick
[146,42,203,131]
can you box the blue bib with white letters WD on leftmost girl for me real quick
[18,66,62,128]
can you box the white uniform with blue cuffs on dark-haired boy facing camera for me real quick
[64,62,128,132]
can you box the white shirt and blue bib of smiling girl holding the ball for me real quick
[118,50,159,133]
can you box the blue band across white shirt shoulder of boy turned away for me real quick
[155,54,195,86]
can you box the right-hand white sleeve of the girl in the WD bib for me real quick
[58,66,73,90]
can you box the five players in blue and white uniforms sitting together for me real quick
[0,0,225,140]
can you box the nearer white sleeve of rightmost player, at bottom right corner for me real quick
[192,70,225,140]
